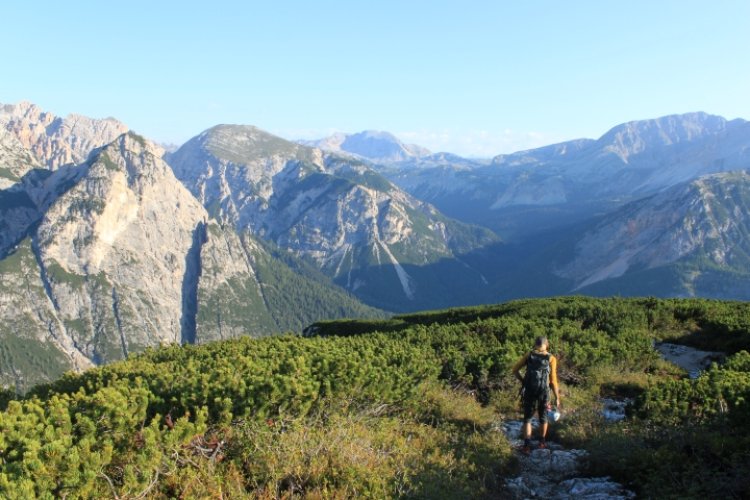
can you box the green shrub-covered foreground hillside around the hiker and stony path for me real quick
[0,297,750,498]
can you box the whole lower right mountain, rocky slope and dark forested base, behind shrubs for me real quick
[556,171,750,300]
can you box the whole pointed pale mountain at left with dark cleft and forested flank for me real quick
[0,133,379,389]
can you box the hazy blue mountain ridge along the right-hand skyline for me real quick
[388,113,750,238]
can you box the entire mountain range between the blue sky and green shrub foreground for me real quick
[0,103,750,391]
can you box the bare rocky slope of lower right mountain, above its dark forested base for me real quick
[558,171,750,288]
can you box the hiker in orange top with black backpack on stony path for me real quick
[513,337,562,453]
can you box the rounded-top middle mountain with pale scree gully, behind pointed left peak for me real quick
[167,125,496,310]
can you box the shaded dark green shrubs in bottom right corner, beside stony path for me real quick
[584,351,750,498]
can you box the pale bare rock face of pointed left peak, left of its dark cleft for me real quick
[35,135,207,361]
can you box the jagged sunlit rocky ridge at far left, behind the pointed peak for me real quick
[0,102,128,170]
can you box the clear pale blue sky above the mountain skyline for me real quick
[0,0,750,156]
